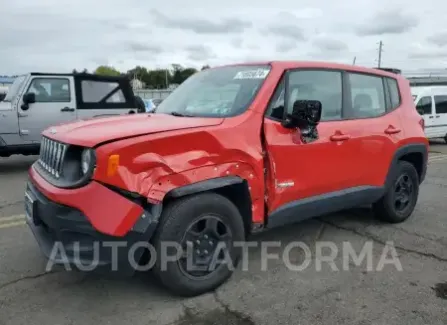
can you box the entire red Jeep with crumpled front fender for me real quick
[25,62,428,295]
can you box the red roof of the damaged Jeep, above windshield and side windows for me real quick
[212,61,406,79]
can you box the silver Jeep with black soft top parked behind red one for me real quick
[0,73,145,157]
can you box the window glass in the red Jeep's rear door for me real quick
[348,73,386,118]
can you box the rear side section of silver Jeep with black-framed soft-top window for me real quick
[75,75,137,119]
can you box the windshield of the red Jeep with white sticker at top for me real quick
[157,65,270,117]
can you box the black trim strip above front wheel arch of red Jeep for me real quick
[165,176,244,198]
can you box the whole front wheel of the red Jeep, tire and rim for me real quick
[152,193,245,296]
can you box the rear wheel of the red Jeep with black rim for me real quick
[373,161,419,223]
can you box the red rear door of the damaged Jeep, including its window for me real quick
[343,71,404,187]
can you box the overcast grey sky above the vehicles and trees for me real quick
[0,0,447,75]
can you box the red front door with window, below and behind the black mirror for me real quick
[264,70,366,215]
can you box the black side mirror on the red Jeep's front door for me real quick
[283,100,321,128]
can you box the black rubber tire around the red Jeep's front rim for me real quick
[151,193,245,297]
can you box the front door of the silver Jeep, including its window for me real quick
[17,76,76,142]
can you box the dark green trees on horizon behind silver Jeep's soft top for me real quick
[73,64,209,89]
